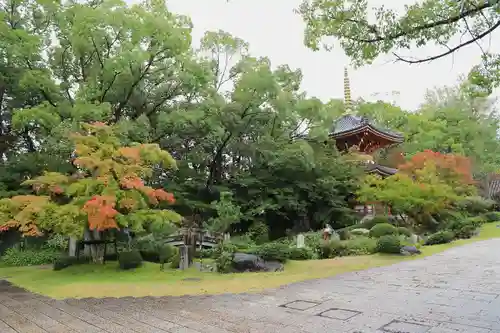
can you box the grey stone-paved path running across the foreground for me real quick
[0,240,500,333]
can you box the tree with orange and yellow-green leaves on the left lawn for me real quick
[0,123,181,260]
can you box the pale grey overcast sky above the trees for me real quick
[167,0,500,110]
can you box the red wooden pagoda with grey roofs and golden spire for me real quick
[329,68,404,216]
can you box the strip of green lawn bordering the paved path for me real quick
[0,222,500,298]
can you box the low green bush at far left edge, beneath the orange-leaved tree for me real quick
[1,248,61,266]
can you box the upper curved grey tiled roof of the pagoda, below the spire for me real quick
[329,114,404,143]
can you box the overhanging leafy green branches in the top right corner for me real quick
[297,0,500,91]
